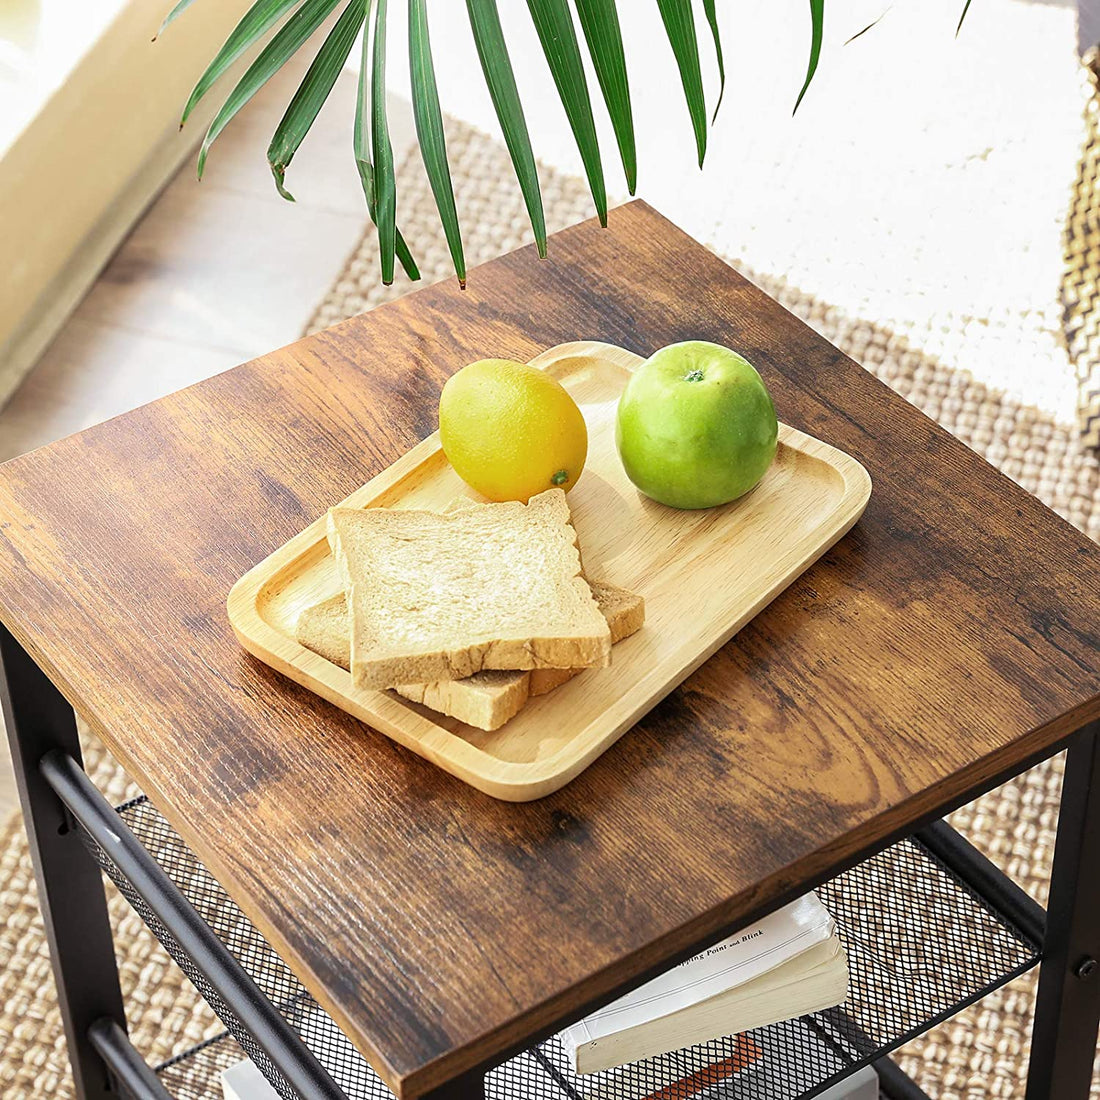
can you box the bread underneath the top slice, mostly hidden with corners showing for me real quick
[295,581,646,729]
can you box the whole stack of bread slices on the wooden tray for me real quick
[295,488,646,729]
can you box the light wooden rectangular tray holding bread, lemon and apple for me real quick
[229,342,871,802]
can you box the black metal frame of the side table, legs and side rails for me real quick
[0,625,1100,1100]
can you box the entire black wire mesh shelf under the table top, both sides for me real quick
[89,799,1038,1100]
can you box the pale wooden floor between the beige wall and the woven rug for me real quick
[0,62,415,817]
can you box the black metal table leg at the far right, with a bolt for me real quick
[1026,722,1100,1100]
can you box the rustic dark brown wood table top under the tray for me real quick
[0,202,1100,1097]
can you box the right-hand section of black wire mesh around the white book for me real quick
[540,840,1037,1100]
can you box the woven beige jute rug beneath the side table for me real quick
[0,125,1100,1100]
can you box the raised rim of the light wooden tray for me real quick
[227,340,871,802]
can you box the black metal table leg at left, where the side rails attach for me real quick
[0,625,125,1100]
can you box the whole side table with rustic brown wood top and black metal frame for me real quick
[0,202,1100,1100]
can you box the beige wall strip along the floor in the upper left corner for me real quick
[0,0,250,403]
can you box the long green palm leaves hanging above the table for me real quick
[162,0,970,286]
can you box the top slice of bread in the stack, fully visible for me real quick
[329,490,612,688]
